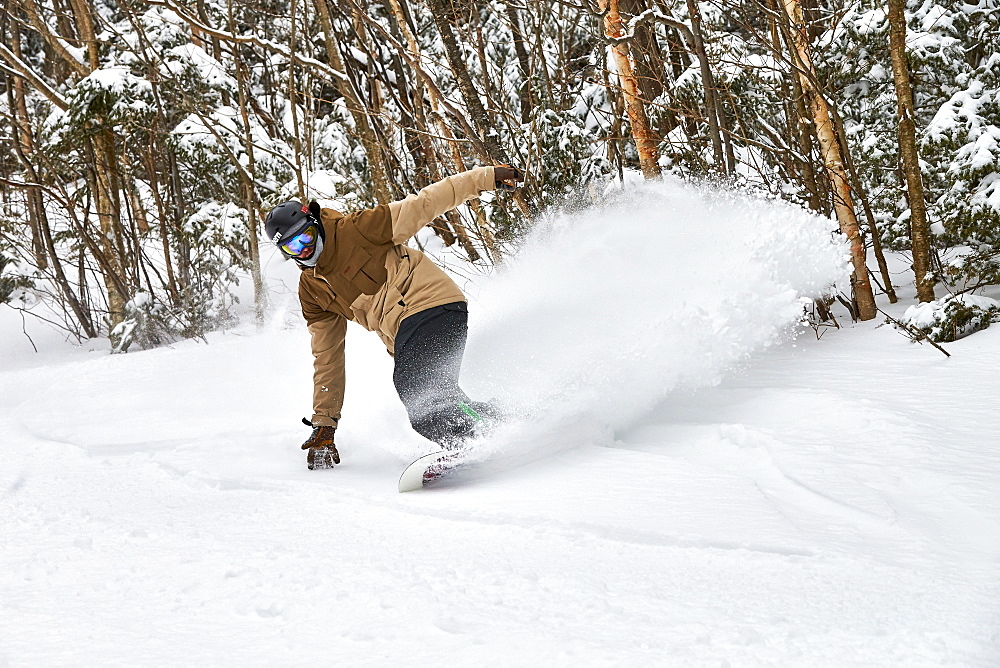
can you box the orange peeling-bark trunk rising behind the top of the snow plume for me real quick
[600,0,660,179]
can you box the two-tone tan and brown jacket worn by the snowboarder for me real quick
[299,167,494,426]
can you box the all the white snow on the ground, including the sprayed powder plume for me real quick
[0,182,1000,666]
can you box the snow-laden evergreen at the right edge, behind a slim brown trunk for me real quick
[827,0,1000,289]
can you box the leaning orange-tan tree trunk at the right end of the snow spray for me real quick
[782,0,877,320]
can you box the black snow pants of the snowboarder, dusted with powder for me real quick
[392,302,477,448]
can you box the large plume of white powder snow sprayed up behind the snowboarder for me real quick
[463,175,848,426]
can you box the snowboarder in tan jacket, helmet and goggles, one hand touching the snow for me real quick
[264,165,524,469]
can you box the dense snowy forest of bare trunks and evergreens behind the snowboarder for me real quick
[0,0,1000,352]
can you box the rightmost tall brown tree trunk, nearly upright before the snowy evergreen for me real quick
[889,0,934,302]
